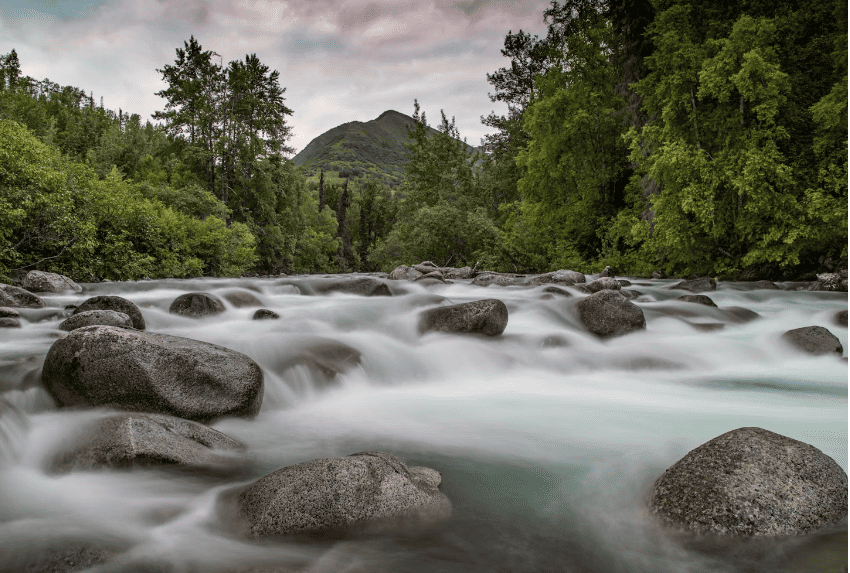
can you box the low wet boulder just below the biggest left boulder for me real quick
[52,413,243,472]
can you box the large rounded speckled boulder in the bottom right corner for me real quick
[650,428,847,535]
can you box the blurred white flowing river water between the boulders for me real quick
[0,277,848,573]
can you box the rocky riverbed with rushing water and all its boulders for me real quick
[0,270,848,573]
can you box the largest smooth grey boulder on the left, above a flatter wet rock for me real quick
[42,326,263,422]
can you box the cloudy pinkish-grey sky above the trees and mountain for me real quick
[0,0,549,151]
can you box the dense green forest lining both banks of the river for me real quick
[0,0,847,281]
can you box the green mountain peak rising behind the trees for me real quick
[292,110,476,185]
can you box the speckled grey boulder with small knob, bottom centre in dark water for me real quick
[239,452,452,538]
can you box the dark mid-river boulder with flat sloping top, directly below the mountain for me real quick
[419,298,508,336]
